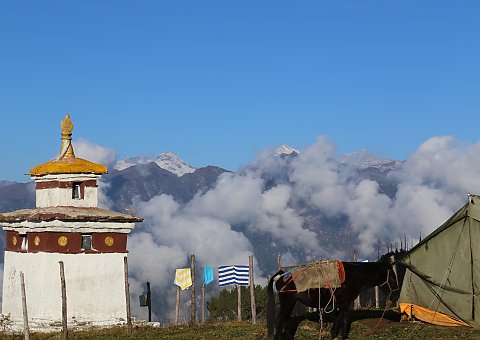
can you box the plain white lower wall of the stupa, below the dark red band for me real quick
[2,251,126,331]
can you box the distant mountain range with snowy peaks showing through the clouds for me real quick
[0,145,402,270]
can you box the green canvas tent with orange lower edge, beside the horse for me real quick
[399,195,480,327]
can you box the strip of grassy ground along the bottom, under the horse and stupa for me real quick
[0,318,480,340]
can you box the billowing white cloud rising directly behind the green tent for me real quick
[347,136,480,254]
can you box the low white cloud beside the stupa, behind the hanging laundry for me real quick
[129,195,253,320]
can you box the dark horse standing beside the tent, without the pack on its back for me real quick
[267,254,400,339]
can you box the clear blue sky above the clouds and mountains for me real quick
[0,0,480,181]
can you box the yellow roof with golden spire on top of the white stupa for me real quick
[30,114,108,176]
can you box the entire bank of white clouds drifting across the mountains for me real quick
[75,136,480,319]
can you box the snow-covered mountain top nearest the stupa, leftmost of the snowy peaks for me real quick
[115,151,197,177]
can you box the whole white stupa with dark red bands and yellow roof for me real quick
[0,114,142,330]
